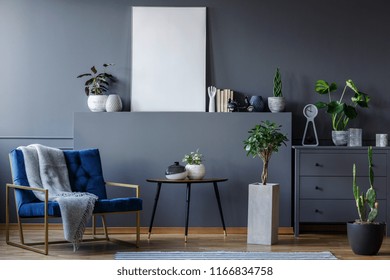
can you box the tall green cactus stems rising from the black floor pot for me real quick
[352,146,378,223]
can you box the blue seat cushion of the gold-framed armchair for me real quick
[19,197,142,218]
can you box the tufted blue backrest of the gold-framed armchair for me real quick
[9,149,107,207]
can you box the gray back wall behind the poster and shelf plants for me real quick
[0,0,390,222]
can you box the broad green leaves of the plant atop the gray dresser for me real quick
[315,80,370,131]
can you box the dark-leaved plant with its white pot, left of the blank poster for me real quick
[77,63,115,112]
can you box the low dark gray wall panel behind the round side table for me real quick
[74,112,292,226]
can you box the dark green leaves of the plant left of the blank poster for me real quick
[77,63,115,96]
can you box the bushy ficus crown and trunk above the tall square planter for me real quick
[244,120,288,185]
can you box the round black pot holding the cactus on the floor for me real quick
[347,222,386,256]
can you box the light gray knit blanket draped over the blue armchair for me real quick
[19,144,98,251]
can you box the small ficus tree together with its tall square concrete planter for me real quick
[244,120,288,245]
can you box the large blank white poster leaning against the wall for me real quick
[131,7,206,112]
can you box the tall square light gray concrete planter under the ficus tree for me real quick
[247,183,279,245]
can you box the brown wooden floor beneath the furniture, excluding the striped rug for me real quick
[0,230,390,260]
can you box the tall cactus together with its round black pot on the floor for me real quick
[347,146,386,255]
